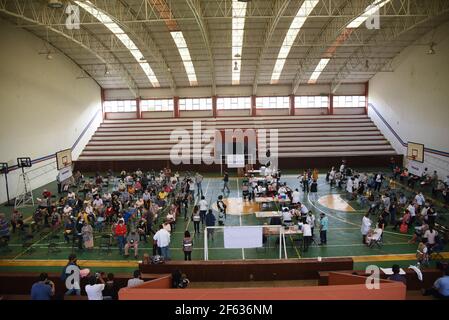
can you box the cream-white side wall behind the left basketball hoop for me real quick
[0,20,101,202]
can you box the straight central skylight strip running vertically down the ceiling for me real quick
[232,0,246,84]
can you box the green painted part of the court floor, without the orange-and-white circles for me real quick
[0,169,448,271]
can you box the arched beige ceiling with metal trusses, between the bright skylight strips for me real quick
[0,0,449,95]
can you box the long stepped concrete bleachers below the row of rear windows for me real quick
[78,115,396,170]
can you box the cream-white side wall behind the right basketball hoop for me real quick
[368,23,449,177]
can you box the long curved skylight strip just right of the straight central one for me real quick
[271,0,319,84]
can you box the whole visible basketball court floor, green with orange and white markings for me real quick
[0,169,449,271]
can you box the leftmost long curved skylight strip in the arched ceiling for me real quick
[75,1,160,87]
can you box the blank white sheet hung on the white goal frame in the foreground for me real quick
[223,226,263,249]
